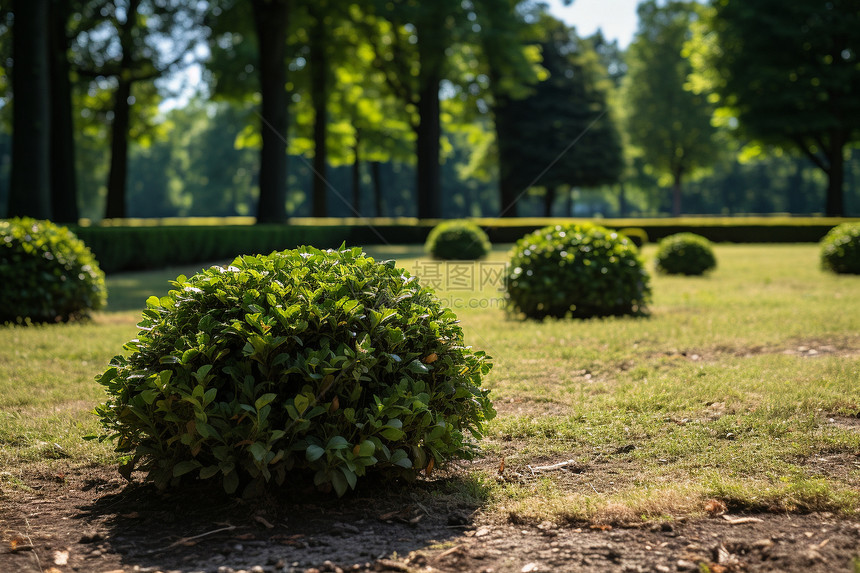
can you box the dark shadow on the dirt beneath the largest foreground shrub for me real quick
[79,477,486,571]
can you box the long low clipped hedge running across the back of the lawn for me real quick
[72,217,849,273]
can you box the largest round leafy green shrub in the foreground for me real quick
[97,247,495,495]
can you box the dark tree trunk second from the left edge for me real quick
[50,0,79,223]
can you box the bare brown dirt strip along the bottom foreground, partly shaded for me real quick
[6,468,860,573]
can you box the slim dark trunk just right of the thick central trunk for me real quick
[308,5,329,217]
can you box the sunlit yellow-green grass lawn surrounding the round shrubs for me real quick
[0,245,860,523]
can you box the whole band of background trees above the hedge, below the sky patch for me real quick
[0,0,860,222]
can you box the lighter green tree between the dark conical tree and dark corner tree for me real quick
[623,0,719,217]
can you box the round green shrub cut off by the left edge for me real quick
[0,217,107,324]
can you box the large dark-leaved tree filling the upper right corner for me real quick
[704,0,860,216]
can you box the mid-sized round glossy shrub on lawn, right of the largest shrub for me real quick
[505,223,651,318]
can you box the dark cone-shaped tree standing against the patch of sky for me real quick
[495,14,623,216]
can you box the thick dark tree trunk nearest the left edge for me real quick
[8,0,52,219]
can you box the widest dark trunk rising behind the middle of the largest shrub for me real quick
[251,0,289,223]
